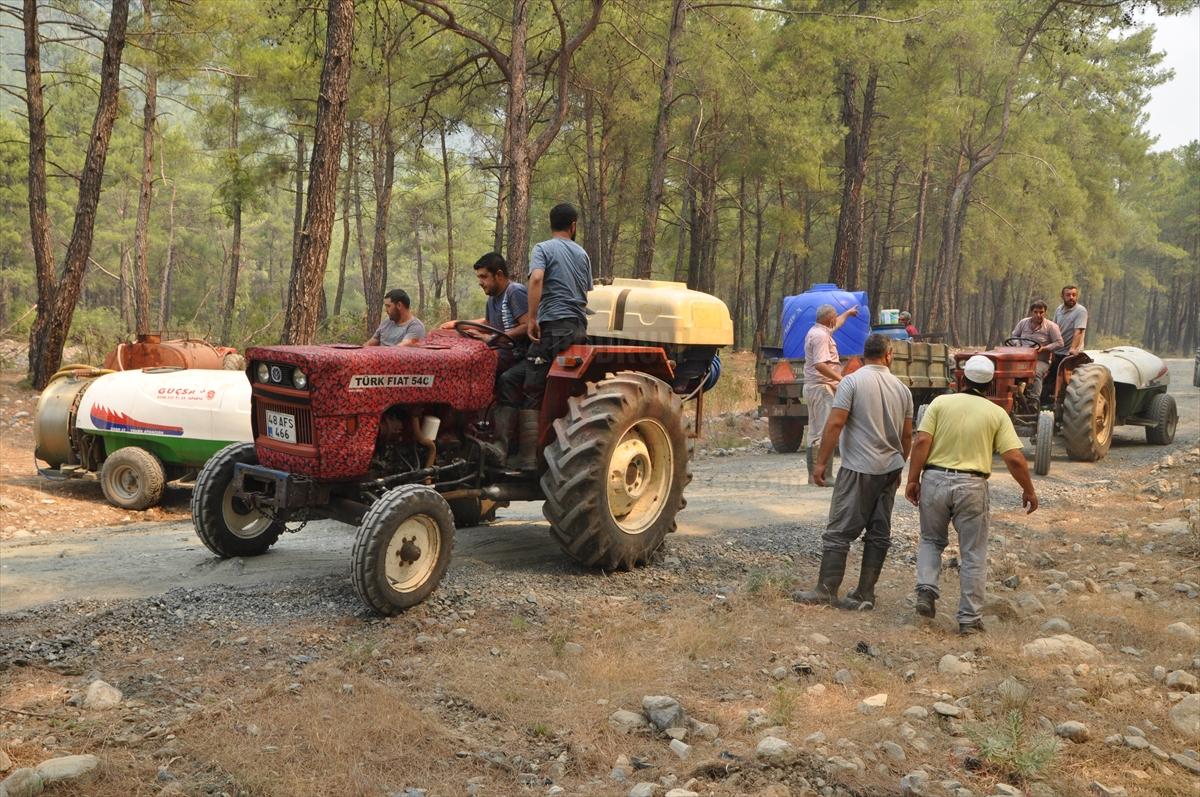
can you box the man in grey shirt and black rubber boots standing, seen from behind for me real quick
[792,335,912,611]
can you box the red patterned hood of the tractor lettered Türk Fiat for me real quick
[246,330,497,414]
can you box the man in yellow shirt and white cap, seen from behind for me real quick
[905,354,1038,634]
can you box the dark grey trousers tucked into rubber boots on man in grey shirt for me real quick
[821,468,900,551]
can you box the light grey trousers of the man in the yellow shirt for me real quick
[917,471,989,623]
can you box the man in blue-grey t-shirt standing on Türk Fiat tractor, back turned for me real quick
[517,203,592,471]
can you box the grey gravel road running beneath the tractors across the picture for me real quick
[0,359,1200,616]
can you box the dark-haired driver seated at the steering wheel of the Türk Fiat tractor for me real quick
[442,252,529,466]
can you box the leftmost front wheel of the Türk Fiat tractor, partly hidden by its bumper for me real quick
[192,443,283,559]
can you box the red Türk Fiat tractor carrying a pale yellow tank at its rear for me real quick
[192,280,732,615]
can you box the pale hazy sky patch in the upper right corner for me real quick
[1139,8,1200,150]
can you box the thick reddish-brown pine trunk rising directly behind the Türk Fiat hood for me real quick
[283,0,354,344]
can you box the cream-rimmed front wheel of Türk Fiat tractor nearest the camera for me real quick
[350,485,454,616]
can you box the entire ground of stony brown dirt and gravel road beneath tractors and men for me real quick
[0,360,1200,797]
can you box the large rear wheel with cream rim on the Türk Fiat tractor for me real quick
[541,371,691,570]
